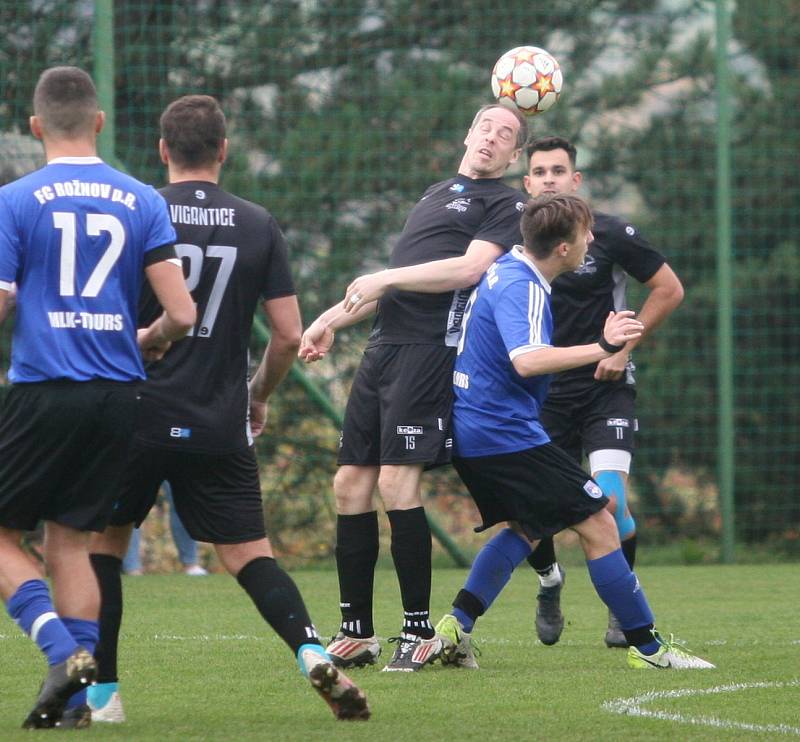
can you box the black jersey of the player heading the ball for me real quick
[369,175,525,347]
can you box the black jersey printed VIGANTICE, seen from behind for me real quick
[137,181,295,453]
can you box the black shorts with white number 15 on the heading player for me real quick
[338,345,455,468]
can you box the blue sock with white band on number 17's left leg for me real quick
[6,580,78,665]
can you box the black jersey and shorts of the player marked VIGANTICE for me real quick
[112,181,295,544]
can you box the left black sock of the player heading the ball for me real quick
[336,510,378,637]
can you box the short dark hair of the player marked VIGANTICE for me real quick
[160,95,225,167]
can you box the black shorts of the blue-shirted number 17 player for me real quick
[0,380,139,531]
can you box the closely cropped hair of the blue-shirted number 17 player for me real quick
[33,67,98,137]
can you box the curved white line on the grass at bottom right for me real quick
[601,680,800,736]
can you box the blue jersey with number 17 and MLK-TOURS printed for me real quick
[0,157,175,383]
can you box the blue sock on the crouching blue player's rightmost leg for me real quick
[586,549,658,649]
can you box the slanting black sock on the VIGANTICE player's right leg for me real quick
[236,557,320,654]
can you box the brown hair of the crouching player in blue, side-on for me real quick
[520,193,594,260]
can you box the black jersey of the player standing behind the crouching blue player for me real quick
[551,211,666,390]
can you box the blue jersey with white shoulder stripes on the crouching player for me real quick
[453,248,553,458]
